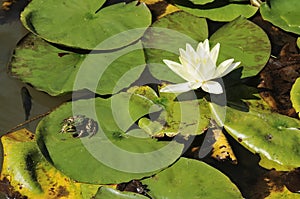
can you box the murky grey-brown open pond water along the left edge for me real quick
[0,0,67,170]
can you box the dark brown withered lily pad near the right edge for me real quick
[259,44,300,117]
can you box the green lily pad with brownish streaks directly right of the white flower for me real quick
[210,17,271,78]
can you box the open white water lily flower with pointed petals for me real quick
[160,39,240,94]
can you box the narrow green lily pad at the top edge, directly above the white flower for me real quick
[174,0,258,22]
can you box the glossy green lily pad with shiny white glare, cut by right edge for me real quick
[214,100,300,171]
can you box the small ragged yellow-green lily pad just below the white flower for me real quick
[129,86,211,137]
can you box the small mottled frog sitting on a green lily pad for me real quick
[60,115,98,138]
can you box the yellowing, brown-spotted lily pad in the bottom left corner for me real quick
[1,129,100,199]
